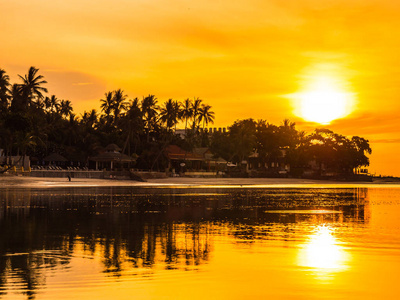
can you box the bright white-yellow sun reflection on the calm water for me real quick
[299,225,349,275]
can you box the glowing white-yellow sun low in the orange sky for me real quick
[291,64,354,125]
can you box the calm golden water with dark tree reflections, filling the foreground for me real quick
[0,187,400,299]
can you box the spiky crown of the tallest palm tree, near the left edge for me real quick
[18,67,47,105]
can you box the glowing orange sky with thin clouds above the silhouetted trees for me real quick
[0,0,400,176]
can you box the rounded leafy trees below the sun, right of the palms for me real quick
[210,119,372,176]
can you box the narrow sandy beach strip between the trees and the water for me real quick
[0,176,400,189]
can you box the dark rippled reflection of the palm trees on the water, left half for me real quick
[0,199,209,292]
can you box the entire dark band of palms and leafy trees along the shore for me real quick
[0,67,371,173]
